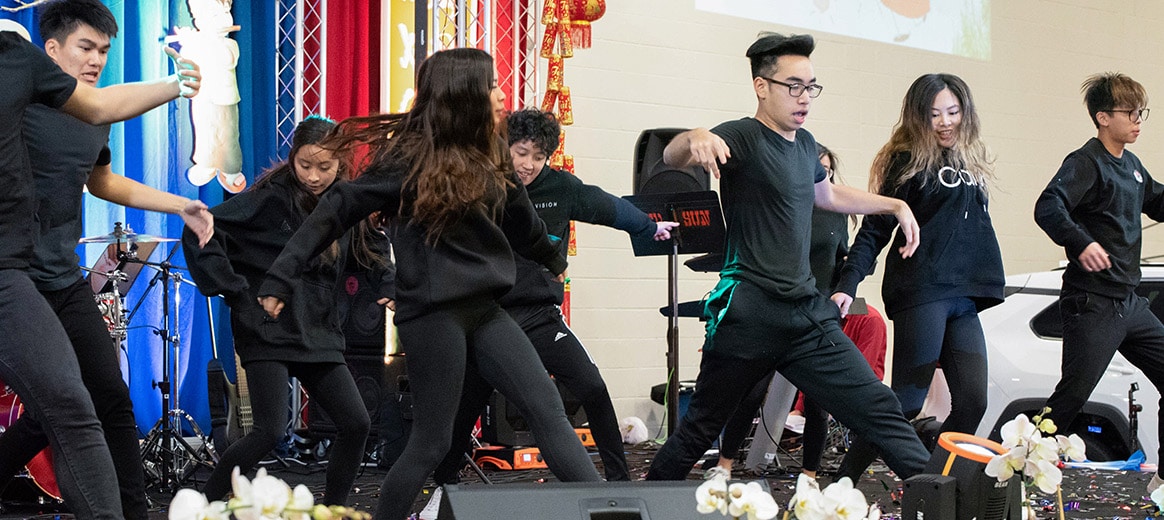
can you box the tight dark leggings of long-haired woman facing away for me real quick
[374,299,601,519]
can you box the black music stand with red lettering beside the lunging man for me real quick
[624,191,725,435]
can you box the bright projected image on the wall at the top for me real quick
[695,0,991,59]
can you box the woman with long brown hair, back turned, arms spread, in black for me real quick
[260,49,599,519]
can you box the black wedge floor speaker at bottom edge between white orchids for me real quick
[437,480,705,520]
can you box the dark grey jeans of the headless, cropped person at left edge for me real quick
[0,269,120,519]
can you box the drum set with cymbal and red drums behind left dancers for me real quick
[0,222,218,503]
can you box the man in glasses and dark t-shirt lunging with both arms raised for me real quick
[647,34,929,480]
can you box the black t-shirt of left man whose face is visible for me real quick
[23,105,112,291]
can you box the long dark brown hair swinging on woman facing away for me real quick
[327,49,513,242]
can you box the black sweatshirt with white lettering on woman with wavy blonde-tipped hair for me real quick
[837,152,1006,319]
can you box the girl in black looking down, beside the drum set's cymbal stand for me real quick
[183,116,392,505]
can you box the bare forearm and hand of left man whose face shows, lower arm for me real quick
[86,164,214,248]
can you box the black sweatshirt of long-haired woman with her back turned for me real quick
[258,165,566,323]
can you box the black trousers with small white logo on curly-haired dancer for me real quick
[433,305,631,485]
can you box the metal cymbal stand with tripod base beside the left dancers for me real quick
[137,252,218,494]
